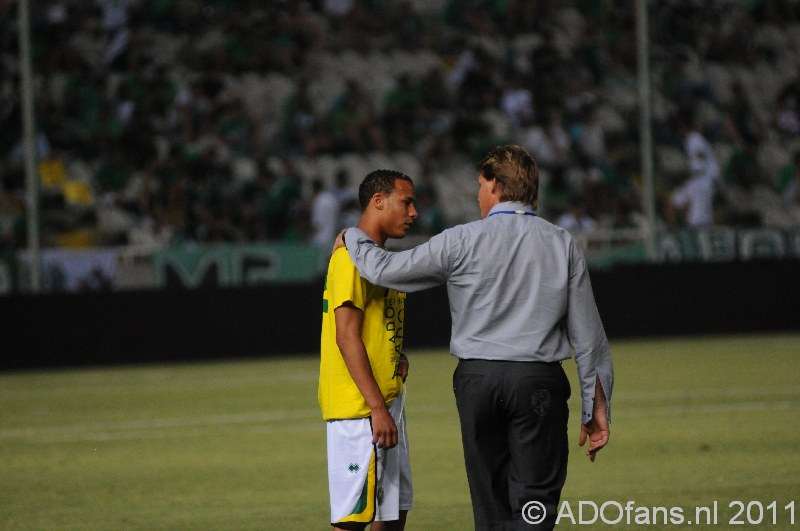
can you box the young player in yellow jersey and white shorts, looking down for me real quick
[319,170,417,530]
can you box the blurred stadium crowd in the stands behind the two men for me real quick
[0,0,800,250]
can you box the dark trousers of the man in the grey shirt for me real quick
[453,360,570,531]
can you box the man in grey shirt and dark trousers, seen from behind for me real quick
[344,145,614,529]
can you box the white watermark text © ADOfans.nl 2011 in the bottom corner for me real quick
[522,500,796,526]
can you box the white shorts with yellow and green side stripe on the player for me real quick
[327,389,413,524]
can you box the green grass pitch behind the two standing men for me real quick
[0,334,800,530]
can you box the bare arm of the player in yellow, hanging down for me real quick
[334,302,397,448]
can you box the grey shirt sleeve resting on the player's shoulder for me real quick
[344,227,450,292]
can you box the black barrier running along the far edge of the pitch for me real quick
[0,260,800,370]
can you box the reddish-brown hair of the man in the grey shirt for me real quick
[475,144,539,208]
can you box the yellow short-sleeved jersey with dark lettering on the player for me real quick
[318,247,406,420]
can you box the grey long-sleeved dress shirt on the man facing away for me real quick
[345,202,614,423]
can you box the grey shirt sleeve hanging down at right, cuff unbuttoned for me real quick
[567,243,614,424]
